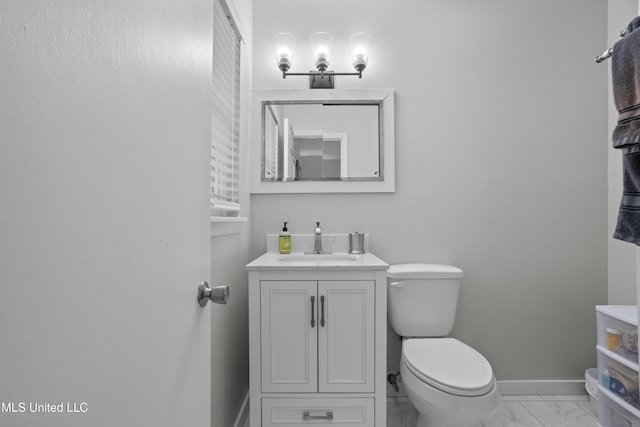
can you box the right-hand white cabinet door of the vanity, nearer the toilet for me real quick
[318,281,375,392]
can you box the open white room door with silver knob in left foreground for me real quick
[0,0,215,427]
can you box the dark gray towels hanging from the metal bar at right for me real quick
[611,17,640,246]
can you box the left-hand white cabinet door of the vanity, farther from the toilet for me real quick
[260,281,318,393]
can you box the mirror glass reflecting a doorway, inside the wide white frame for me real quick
[261,100,383,182]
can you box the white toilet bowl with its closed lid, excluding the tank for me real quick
[400,338,500,427]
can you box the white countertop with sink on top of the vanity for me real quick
[246,252,389,271]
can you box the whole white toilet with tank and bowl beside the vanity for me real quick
[387,264,500,427]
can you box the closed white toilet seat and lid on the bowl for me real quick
[402,338,494,396]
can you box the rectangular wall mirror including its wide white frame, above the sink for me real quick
[251,90,395,193]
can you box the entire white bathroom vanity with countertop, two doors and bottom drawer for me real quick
[247,235,388,427]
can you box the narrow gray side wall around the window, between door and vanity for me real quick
[211,0,253,427]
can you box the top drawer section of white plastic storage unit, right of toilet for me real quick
[596,305,638,364]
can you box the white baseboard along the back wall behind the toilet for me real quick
[387,380,587,399]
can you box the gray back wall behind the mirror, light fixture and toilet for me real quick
[251,0,609,380]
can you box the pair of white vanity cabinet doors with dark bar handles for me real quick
[260,280,375,393]
